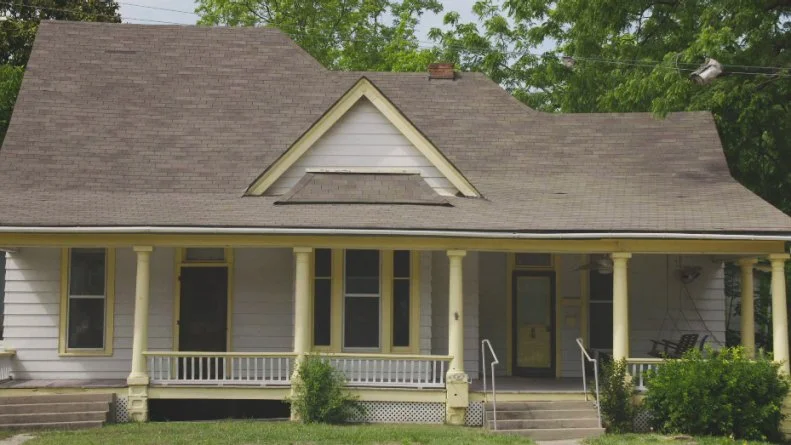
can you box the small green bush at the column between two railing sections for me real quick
[291,356,364,423]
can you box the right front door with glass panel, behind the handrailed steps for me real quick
[511,271,555,377]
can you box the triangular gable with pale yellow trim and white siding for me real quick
[247,78,479,197]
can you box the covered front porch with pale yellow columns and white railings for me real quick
[0,236,788,423]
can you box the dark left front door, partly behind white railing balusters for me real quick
[178,266,228,379]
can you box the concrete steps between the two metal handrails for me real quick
[485,400,604,440]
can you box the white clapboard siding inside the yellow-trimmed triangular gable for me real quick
[267,98,457,196]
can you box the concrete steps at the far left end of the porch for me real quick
[0,394,114,431]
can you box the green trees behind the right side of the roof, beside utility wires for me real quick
[430,0,791,213]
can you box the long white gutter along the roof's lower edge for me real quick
[0,226,791,241]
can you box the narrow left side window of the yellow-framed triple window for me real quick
[313,249,332,346]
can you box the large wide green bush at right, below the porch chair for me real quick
[644,348,789,440]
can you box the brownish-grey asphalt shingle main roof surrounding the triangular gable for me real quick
[0,22,791,233]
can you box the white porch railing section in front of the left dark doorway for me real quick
[144,351,296,386]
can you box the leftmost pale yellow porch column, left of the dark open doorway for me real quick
[126,246,154,422]
